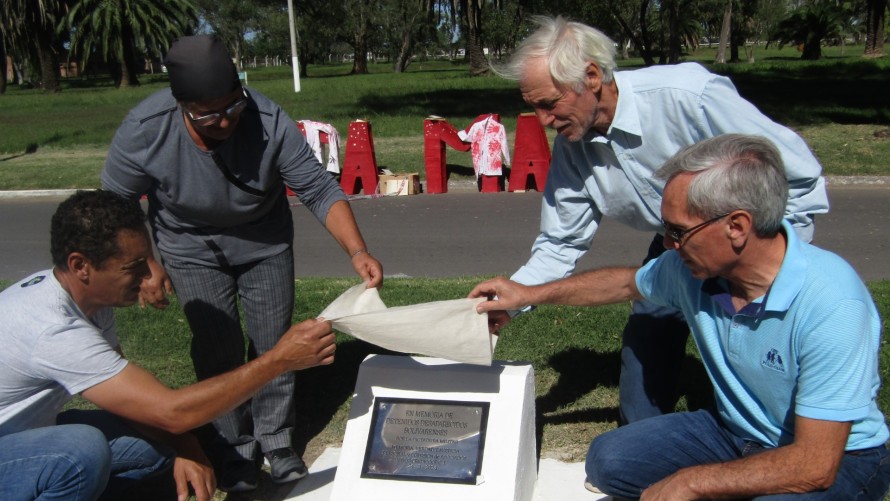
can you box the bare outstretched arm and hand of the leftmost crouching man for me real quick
[83,320,335,434]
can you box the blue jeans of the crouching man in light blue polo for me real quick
[585,410,890,501]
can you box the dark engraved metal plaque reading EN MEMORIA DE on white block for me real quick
[362,398,489,484]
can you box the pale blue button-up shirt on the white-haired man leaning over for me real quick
[512,63,828,285]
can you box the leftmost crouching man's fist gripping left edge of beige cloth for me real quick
[274,319,337,371]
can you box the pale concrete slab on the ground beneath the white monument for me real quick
[285,447,613,501]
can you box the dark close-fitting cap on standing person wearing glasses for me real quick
[164,35,241,102]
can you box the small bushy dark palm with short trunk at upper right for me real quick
[774,0,844,60]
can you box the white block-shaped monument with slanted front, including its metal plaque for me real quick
[330,355,537,501]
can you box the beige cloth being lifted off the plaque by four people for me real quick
[319,283,497,365]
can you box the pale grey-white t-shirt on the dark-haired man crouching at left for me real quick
[0,270,127,436]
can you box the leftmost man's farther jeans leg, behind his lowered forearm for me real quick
[56,410,176,500]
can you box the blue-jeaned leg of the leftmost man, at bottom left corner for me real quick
[0,424,111,501]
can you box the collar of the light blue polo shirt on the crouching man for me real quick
[702,221,807,319]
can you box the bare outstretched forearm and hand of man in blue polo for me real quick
[470,268,640,313]
